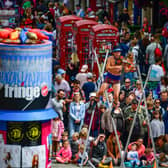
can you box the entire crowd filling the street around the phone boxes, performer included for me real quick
[2,0,168,167]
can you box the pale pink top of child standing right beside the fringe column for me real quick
[51,120,64,141]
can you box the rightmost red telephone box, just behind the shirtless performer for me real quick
[89,24,119,76]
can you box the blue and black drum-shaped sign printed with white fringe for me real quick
[0,44,52,110]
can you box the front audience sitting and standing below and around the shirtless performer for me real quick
[52,65,168,167]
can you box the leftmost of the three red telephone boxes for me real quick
[56,15,82,69]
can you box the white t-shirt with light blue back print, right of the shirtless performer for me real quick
[149,64,164,81]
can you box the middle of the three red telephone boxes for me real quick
[74,20,98,68]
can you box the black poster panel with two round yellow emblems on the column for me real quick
[7,122,41,146]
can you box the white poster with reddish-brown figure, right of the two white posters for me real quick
[22,145,46,168]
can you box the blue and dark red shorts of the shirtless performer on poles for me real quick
[104,72,121,84]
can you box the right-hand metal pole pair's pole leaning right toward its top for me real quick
[121,66,151,167]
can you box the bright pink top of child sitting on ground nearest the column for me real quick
[57,147,72,161]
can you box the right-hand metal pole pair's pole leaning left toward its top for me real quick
[137,65,159,167]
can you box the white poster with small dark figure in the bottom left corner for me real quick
[0,145,21,168]
